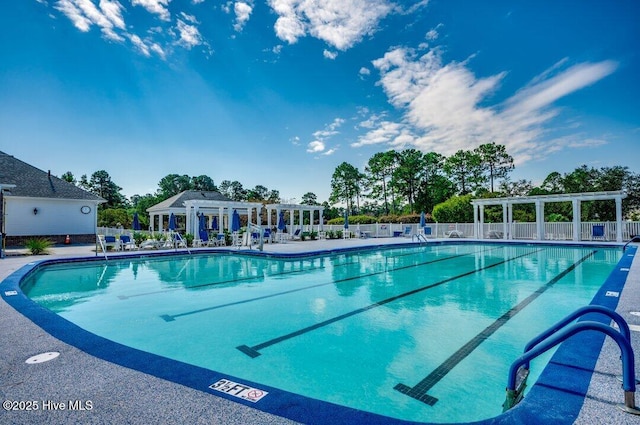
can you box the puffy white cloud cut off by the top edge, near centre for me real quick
[269,0,393,51]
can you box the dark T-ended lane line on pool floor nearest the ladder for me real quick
[393,251,598,406]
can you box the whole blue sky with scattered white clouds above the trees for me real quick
[0,0,640,202]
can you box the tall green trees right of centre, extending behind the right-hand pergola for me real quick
[329,142,640,222]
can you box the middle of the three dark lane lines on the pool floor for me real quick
[236,245,542,358]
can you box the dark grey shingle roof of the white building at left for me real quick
[0,151,104,202]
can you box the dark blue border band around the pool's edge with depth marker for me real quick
[0,241,636,424]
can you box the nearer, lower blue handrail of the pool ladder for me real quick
[503,321,640,415]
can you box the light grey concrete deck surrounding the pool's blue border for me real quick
[0,238,640,425]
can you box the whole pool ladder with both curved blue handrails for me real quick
[502,305,640,415]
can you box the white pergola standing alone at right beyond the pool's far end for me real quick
[471,190,627,242]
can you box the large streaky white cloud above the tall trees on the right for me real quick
[360,48,617,163]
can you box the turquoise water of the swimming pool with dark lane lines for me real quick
[12,244,621,422]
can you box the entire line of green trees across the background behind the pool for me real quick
[61,142,640,227]
